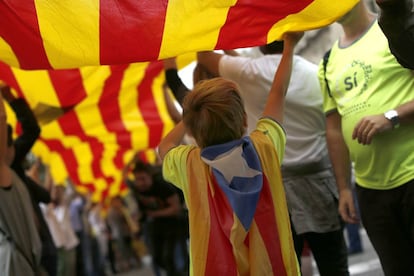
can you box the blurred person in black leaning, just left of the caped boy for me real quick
[124,157,189,276]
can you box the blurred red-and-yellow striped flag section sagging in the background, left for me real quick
[0,62,174,200]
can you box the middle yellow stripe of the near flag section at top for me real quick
[159,0,237,59]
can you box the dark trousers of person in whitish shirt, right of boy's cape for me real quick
[303,229,349,276]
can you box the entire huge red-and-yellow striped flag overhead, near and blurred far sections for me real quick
[0,0,359,199]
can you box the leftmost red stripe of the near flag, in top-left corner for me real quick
[0,0,51,69]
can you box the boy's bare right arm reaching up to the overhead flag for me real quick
[263,32,303,123]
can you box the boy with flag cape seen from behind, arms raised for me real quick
[159,33,303,276]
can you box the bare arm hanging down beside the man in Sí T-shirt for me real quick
[326,111,358,223]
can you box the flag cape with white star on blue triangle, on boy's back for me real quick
[177,131,300,276]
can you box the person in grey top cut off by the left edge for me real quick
[0,86,41,276]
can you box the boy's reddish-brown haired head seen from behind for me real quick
[183,78,247,148]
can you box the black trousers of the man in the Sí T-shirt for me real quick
[357,183,414,276]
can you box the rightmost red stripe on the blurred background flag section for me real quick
[138,61,164,148]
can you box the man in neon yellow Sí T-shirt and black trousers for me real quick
[319,1,414,276]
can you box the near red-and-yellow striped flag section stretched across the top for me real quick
[0,0,359,69]
